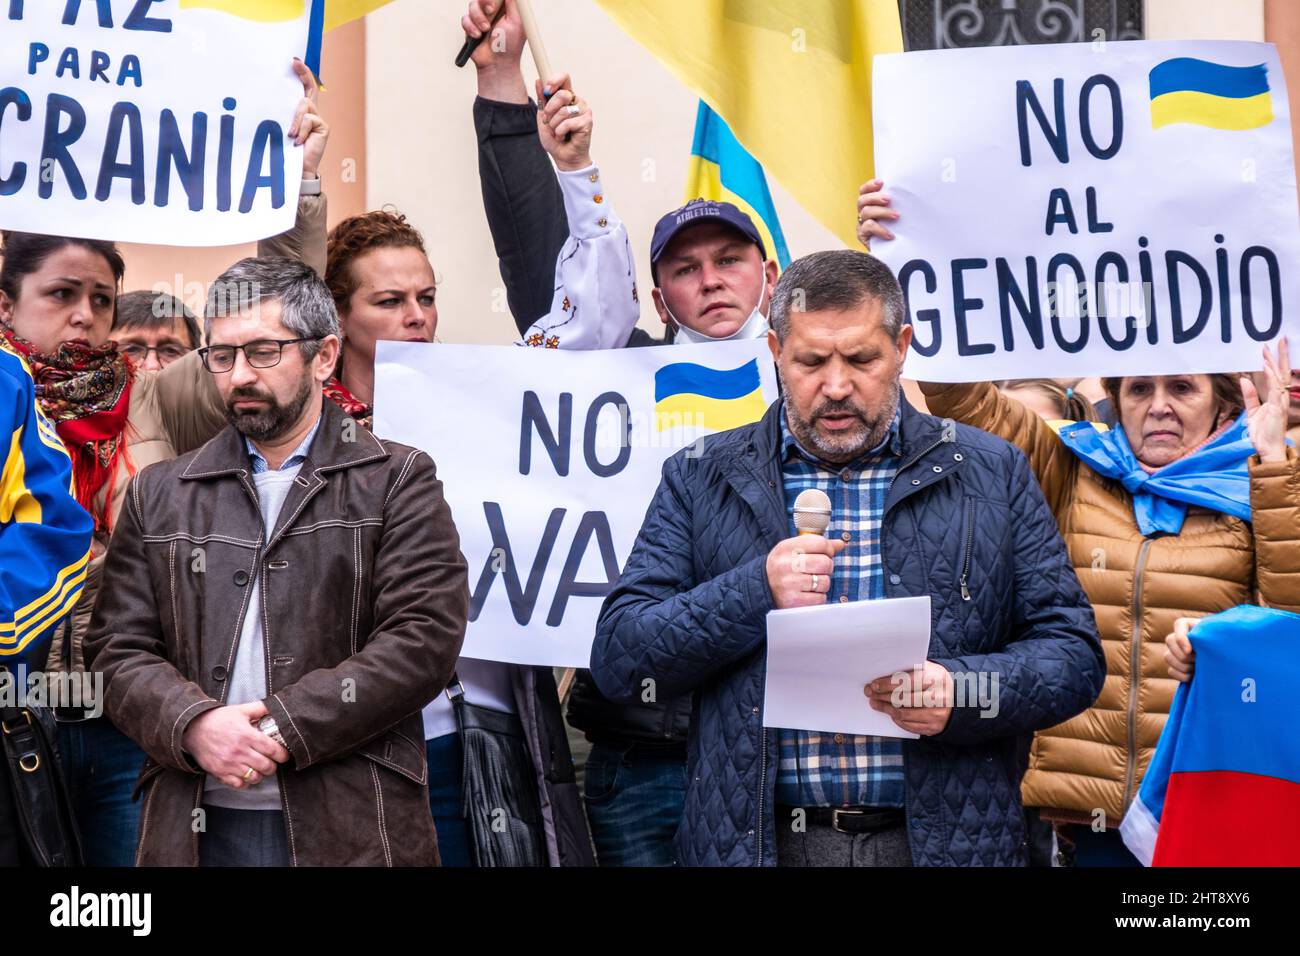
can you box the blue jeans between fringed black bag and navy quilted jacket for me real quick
[582,744,686,866]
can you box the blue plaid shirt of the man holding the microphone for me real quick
[776,411,904,806]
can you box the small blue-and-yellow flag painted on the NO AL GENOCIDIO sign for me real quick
[1151,56,1273,130]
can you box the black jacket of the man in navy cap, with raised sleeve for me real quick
[475,96,690,757]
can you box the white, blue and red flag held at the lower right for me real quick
[1119,605,1300,866]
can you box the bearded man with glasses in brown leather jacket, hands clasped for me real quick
[86,259,468,866]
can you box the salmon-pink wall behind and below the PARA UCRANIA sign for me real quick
[122,21,365,335]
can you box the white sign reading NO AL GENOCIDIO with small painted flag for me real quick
[872,40,1300,381]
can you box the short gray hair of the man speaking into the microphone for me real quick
[767,248,907,342]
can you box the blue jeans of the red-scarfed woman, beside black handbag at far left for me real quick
[59,717,144,866]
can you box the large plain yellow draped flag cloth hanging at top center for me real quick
[597,0,902,247]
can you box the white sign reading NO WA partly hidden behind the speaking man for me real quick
[374,339,777,667]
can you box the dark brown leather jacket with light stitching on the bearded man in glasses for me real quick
[86,401,469,866]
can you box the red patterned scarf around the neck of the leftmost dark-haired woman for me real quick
[0,326,135,533]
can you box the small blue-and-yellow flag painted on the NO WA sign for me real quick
[654,359,767,432]
